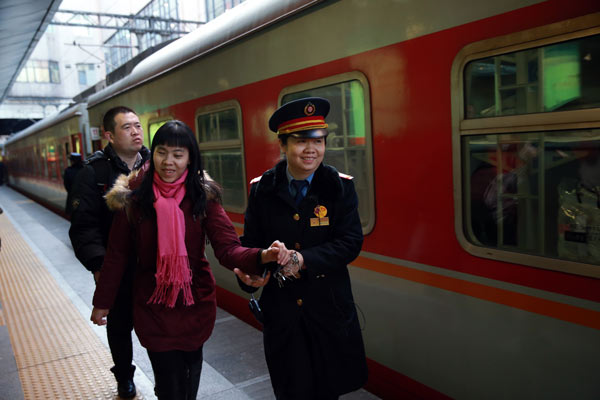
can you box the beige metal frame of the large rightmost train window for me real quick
[451,13,600,278]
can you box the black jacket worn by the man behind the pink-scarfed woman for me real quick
[69,144,150,272]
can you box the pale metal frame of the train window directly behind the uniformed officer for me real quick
[277,71,377,235]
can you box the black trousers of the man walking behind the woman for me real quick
[106,271,135,382]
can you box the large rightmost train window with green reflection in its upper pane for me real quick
[453,18,600,277]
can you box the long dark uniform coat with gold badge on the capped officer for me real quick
[242,160,367,399]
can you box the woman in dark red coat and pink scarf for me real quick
[91,121,289,399]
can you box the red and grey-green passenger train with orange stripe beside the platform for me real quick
[4,0,600,399]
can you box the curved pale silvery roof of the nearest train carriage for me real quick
[87,0,323,107]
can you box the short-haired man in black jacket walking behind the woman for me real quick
[69,106,150,398]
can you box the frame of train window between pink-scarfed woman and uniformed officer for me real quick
[194,99,248,214]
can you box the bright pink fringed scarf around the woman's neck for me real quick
[148,170,194,308]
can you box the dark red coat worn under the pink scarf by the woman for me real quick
[93,198,259,351]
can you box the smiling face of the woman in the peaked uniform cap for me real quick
[279,136,325,179]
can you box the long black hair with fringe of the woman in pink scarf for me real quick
[136,120,221,217]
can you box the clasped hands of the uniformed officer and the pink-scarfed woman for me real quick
[233,240,304,287]
